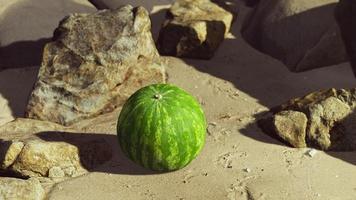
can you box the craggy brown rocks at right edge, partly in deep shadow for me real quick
[260,89,356,151]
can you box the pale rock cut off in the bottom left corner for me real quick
[0,178,45,200]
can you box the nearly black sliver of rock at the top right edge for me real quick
[335,0,356,76]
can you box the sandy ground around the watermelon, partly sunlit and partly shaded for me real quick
[0,1,356,200]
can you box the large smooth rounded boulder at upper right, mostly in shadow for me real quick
[242,0,348,72]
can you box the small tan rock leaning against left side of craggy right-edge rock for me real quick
[273,110,308,148]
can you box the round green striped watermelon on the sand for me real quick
[117,84,207,172]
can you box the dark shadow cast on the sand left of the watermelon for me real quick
[36,131,159,175]
